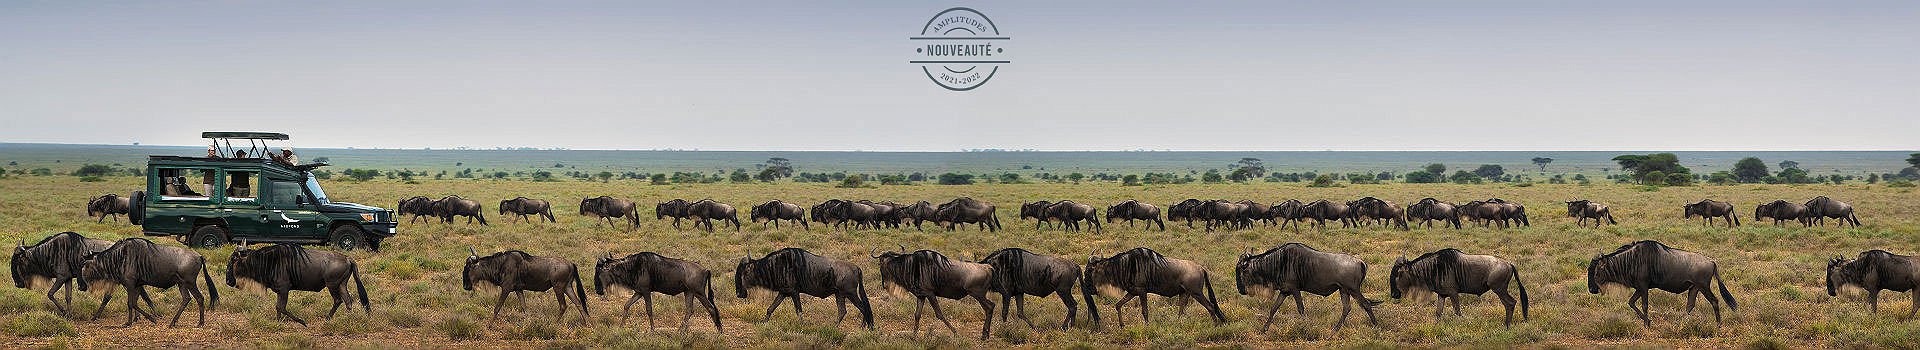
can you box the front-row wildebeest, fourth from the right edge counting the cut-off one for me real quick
[1233,242,1380,331]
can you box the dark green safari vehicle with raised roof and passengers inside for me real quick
[127,133,399,250]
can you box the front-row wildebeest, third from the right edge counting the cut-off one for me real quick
[1386,248,1532,329]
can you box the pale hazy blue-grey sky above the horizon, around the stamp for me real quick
[0,0,1920,150]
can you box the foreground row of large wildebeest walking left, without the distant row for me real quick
[12,227,1920,338]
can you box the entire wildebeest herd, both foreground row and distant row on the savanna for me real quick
[12,196,1896,338]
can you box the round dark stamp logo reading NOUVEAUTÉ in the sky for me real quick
[910,8,1012,90]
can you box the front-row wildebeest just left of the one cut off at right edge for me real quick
[1586,240,1740,327]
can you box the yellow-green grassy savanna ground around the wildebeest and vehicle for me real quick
[0,175,1920,348]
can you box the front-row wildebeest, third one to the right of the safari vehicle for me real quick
[733,248,874,329]
